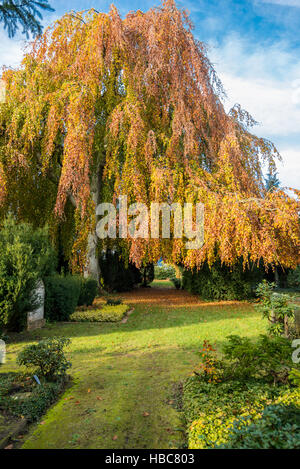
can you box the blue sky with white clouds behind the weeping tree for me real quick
[0,0,300,189]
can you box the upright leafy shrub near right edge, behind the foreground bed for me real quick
[256,280,294,336]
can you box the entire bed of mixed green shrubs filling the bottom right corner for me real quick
[182,336,300,449]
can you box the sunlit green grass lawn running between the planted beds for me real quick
[1,288,266,449]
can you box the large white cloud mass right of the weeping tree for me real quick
[209,36,300,188]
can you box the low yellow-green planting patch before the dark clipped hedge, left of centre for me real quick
[70,305,129,322]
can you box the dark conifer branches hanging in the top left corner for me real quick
[0,0,54,38]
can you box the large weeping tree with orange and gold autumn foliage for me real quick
[0,0,299,282]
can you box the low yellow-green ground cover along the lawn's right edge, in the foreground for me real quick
[183,376,287,449]
